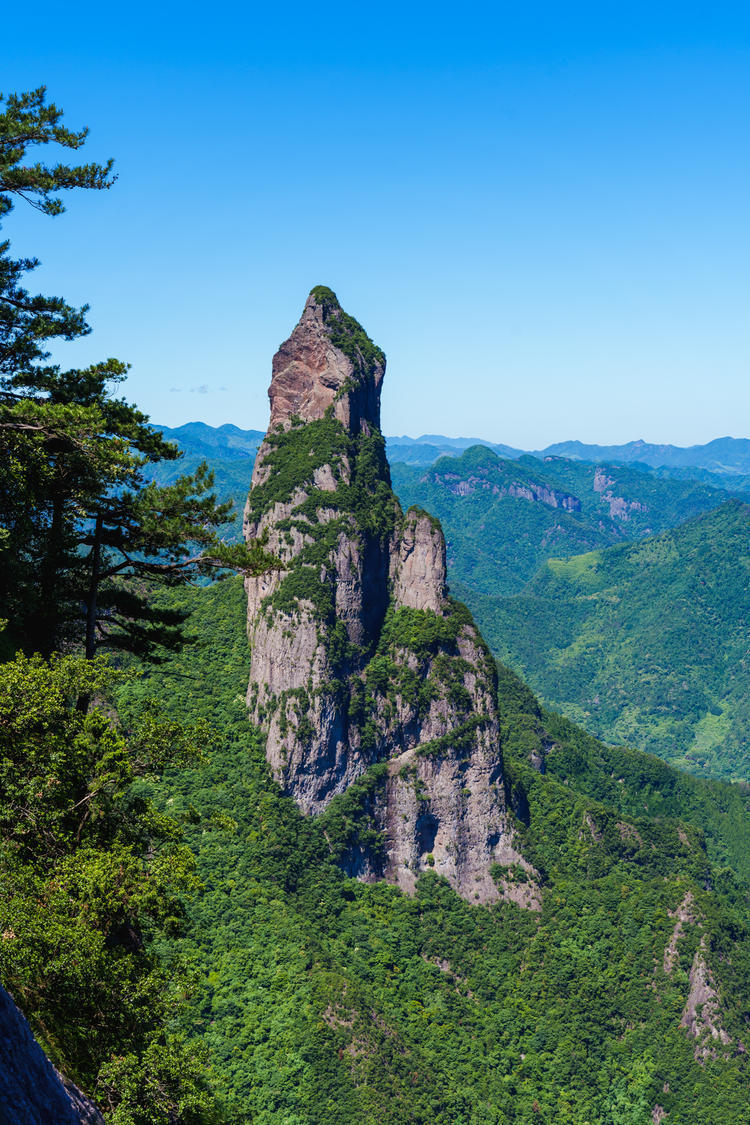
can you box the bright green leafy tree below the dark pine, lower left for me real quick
[0,656,222,1125]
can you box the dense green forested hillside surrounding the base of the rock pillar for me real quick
[114,581,750,1125]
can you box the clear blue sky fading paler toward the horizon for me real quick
[0,0,750,448]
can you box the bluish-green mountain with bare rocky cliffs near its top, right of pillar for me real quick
[391,446,730,595]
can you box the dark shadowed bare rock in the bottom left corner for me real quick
[0,987,103,1125]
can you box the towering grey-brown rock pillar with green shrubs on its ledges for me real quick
[245,287,533,905]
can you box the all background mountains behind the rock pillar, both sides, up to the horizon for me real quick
[154,422,750,779]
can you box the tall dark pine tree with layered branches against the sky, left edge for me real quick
[0,88,273,657]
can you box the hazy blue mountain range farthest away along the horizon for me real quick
[156,422,750,474]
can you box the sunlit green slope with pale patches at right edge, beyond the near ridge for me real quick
[470,501,750,780]
